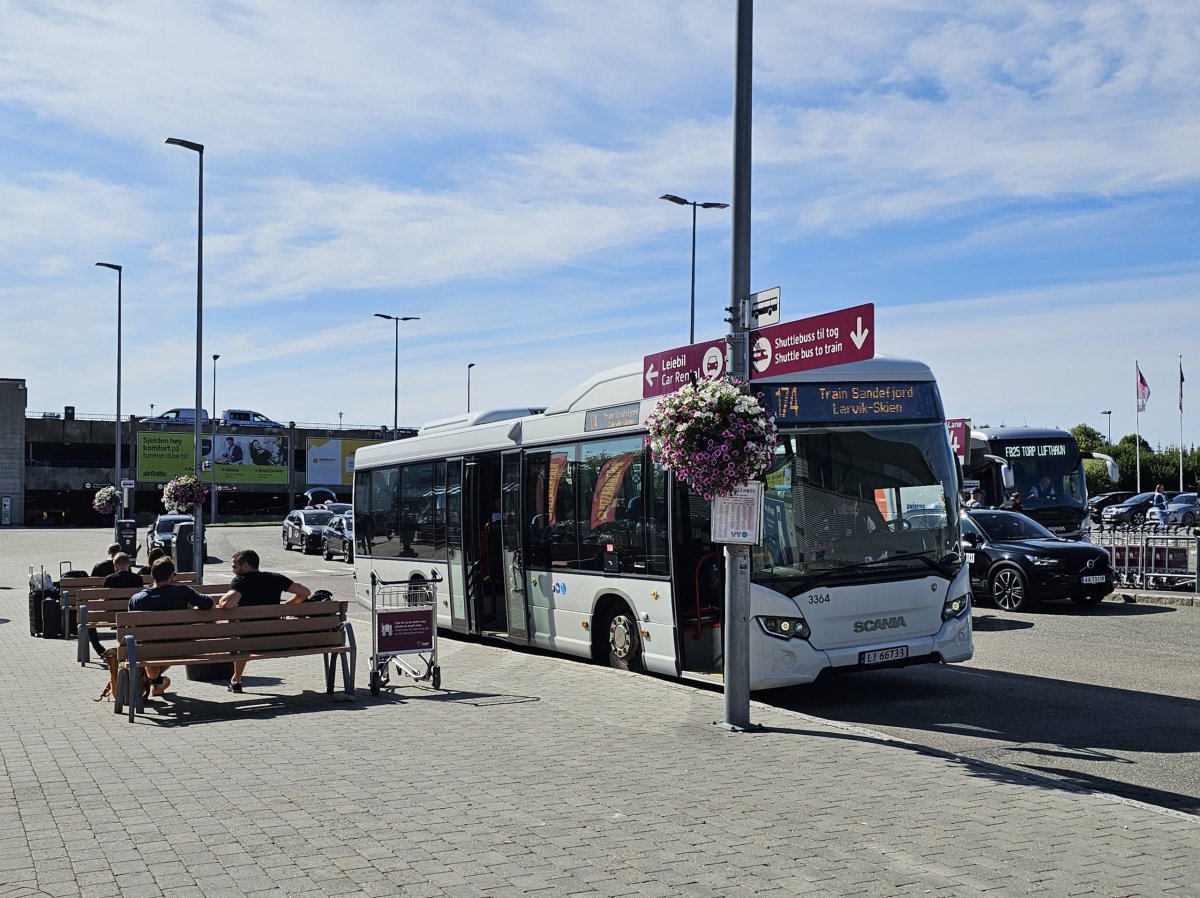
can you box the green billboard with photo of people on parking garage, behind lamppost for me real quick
[138,431,288,485]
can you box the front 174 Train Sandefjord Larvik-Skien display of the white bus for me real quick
[764,381,942,425]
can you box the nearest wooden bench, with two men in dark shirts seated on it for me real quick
[114,601,358,722]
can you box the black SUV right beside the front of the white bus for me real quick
[961,509,1112,611]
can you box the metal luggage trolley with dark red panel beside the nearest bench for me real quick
[371,570,442,695]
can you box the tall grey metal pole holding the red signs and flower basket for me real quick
[724,0,754,732]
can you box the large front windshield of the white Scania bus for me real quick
[751,423,960,595]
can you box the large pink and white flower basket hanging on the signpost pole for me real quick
[646,379,775,499]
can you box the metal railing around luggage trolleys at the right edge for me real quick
[1090,525,1200,593]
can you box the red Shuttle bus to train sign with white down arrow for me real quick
[750,303,875,381]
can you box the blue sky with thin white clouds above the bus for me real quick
[0,0,1200,445]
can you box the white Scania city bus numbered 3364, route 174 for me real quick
[354,358,973,689]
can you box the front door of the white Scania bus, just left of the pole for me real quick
[671,478,725,672]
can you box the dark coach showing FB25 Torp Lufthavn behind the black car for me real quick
[962,427,1118,539]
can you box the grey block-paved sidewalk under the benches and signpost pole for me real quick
[0,532,1200,898]
